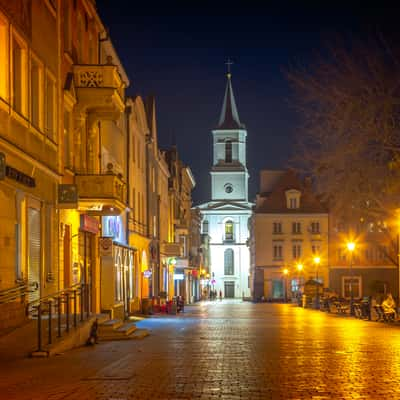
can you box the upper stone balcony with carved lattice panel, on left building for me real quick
[73,64,125,119]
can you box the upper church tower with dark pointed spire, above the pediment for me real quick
[211,73,249,202]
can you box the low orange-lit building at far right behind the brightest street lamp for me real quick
[329,215,399,302]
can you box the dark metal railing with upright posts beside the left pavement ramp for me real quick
[27,284,91,352]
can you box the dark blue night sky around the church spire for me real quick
[97,0,400,204]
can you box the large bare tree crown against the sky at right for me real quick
[288,39,400,221]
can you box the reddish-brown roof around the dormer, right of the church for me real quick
[254,170,328,214]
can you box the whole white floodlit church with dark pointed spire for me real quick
[198,73,253,298]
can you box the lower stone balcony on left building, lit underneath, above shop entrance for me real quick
[75,174,126,215]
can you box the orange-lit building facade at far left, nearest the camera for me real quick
[0,0,62,329]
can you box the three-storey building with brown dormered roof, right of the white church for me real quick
[250,170,329,301]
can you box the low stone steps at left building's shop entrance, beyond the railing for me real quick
[97,319,149,341]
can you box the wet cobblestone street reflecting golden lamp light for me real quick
[0,301,400,400]
